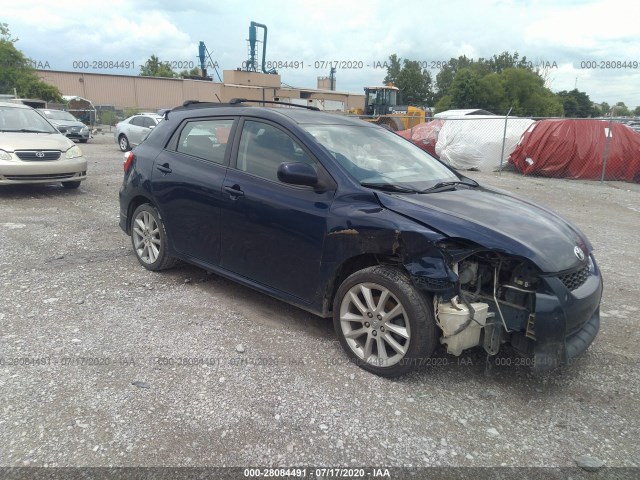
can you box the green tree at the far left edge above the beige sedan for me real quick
[0,23,63,102]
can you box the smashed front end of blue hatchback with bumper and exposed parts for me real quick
[404,239,602,372]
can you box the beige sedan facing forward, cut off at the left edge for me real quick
[0,102,87,188]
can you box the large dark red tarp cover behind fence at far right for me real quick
[509,120,640,182]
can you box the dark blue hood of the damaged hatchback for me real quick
[377,187,591,273]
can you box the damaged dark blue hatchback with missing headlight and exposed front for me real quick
[120,101,602,377]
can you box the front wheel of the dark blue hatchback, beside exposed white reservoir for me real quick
[333,265,437,377]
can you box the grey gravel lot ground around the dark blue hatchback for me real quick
[0,135,640,467]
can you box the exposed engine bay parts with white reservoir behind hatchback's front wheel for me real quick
[434,251,540,355]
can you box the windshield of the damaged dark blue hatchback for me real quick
[302,125,460,191]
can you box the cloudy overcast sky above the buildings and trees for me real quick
[5,0,640,107]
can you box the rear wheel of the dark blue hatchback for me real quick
[131,203,176,271]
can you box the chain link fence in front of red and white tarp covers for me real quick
[360,115,640,183]
